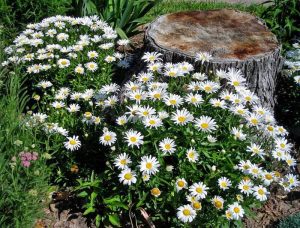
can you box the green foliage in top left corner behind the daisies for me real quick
[0,0,72,43]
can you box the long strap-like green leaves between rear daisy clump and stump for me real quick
[73,0,160,38]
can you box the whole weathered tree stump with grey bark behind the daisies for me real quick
[145,9,283,109]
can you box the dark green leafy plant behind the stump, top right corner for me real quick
[261,0,300,48]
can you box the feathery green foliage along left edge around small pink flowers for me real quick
[0,71,50,228]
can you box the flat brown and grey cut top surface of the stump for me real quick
[146,9,279,61]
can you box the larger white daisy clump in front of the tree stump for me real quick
[101,53,299,225]
